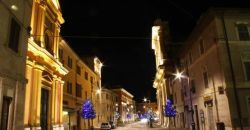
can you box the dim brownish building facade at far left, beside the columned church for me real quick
[0,0,32,130]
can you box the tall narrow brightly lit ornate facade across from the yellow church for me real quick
[152,19,172,126]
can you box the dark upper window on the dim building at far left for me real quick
[8,18,21,52]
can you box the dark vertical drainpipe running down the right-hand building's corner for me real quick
[221,14,243,130]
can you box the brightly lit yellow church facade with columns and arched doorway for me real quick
[24,0,68,130]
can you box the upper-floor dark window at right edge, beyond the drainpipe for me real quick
[237,24,250,41]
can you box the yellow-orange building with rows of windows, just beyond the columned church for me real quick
[59,39,102,130]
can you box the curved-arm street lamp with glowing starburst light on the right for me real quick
[174,70,195,130]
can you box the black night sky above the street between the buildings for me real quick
[60,0,250,101]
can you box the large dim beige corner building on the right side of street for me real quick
[173,8,250,130]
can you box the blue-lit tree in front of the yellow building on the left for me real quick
[82,100,95,128]
